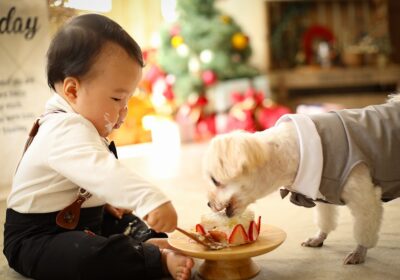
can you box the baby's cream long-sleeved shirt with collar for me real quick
[7,94,169,218]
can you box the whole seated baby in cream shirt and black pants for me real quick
[4,14,193,280]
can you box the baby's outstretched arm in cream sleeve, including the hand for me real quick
[47,114,172,221]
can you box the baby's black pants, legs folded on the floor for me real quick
[3,207,166,280]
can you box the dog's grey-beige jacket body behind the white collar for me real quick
[310,102,400,204]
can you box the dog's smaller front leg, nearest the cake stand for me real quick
[301,203,338,247]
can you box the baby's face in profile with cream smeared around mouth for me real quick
[74,43,142,137]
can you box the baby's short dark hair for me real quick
[47,14,144,90]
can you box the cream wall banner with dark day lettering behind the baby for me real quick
[0,0,51,199]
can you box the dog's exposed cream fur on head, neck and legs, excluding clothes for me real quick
[204,95,400,264]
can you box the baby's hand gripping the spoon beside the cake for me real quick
[144,202,178,232]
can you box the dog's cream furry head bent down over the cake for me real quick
[203,131,268,217]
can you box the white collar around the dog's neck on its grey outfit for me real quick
[275,114,324,200]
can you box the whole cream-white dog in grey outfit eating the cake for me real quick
[204,95,400,264]
